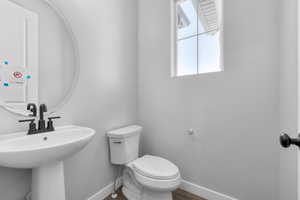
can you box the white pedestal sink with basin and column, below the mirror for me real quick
[0,126,95,200]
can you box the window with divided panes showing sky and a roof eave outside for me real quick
[173,0,223,76]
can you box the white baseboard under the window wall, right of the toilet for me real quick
[180,180,238,200]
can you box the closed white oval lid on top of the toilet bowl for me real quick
[132,156,179,180]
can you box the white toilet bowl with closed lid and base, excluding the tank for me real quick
[123,155,181,200]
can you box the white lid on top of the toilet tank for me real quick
[107,125,143,138]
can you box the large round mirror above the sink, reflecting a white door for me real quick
[0,0,80,116]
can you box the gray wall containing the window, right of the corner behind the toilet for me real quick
[138,0,279,200]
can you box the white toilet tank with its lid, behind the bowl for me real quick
[107,125,143,165]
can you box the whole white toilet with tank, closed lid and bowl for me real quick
[107,125,181,200]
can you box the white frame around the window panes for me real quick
[170,0,224,78]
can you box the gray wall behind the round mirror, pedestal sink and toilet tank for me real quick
[0,0,137,200]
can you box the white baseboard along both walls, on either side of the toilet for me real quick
[87,178,238,200]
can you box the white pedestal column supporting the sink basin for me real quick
[32,162,66,200]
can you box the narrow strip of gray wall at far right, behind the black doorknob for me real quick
[279,0,298,200]
